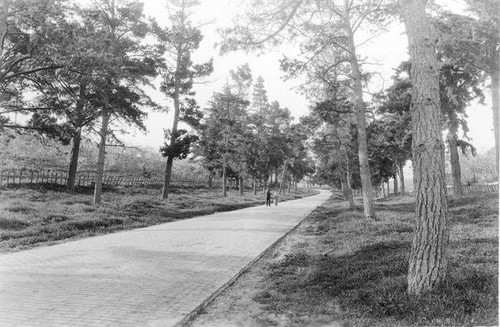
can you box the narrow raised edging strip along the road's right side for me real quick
[174,191,334,327]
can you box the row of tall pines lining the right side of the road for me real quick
[223,0,500,295]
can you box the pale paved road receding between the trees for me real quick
[0,191,331,327]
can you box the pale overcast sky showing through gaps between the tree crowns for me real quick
[125,0,494,152]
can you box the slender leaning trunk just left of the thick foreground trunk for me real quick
[344,0,376,219]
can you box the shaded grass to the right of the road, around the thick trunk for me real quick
[191,194,498,327]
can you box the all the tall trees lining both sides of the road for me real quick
[0,0,500,295]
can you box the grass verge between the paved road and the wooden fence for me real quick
[0,186,317,253]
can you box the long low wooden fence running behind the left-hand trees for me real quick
[0,170,214,187]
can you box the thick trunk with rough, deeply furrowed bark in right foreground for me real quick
[399,0,448,295]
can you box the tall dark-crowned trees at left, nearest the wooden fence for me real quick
[0,0,217,203]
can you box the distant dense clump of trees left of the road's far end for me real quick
[195,64,313,196]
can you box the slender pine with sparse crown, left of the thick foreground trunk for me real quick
[223,0,390,218]
